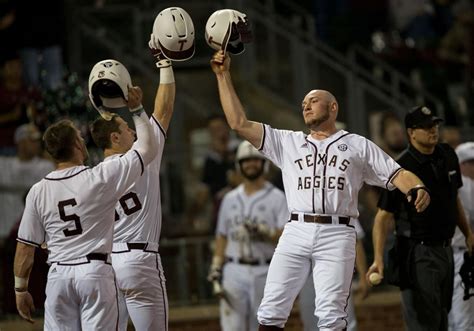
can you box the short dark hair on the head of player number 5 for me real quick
[43,120,77,162]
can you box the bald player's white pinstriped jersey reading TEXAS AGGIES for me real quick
[259,124,401,218]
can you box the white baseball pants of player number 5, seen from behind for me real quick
[44,261,118,331]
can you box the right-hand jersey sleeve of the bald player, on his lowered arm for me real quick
[362,139,402,190]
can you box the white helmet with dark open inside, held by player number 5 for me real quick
[89,60,132,120]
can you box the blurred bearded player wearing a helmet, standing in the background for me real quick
[208,141,288,331]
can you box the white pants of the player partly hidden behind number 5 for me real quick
[112,250,168,331]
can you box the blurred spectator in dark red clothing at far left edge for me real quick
[0,57,40,154]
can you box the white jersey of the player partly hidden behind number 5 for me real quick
[105,116,166,243]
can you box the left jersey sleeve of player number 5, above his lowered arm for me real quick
[17,189,45,247]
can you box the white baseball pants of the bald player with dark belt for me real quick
[258,222,356,331]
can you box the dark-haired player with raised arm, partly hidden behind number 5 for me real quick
[91,40,176,331]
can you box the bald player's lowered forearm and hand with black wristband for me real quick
[392,169,430,213]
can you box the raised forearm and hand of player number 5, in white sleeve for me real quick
[127,87,158,166]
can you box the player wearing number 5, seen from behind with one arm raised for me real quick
[14,87,158,330]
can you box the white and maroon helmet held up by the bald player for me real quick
[205,9,252,55]
